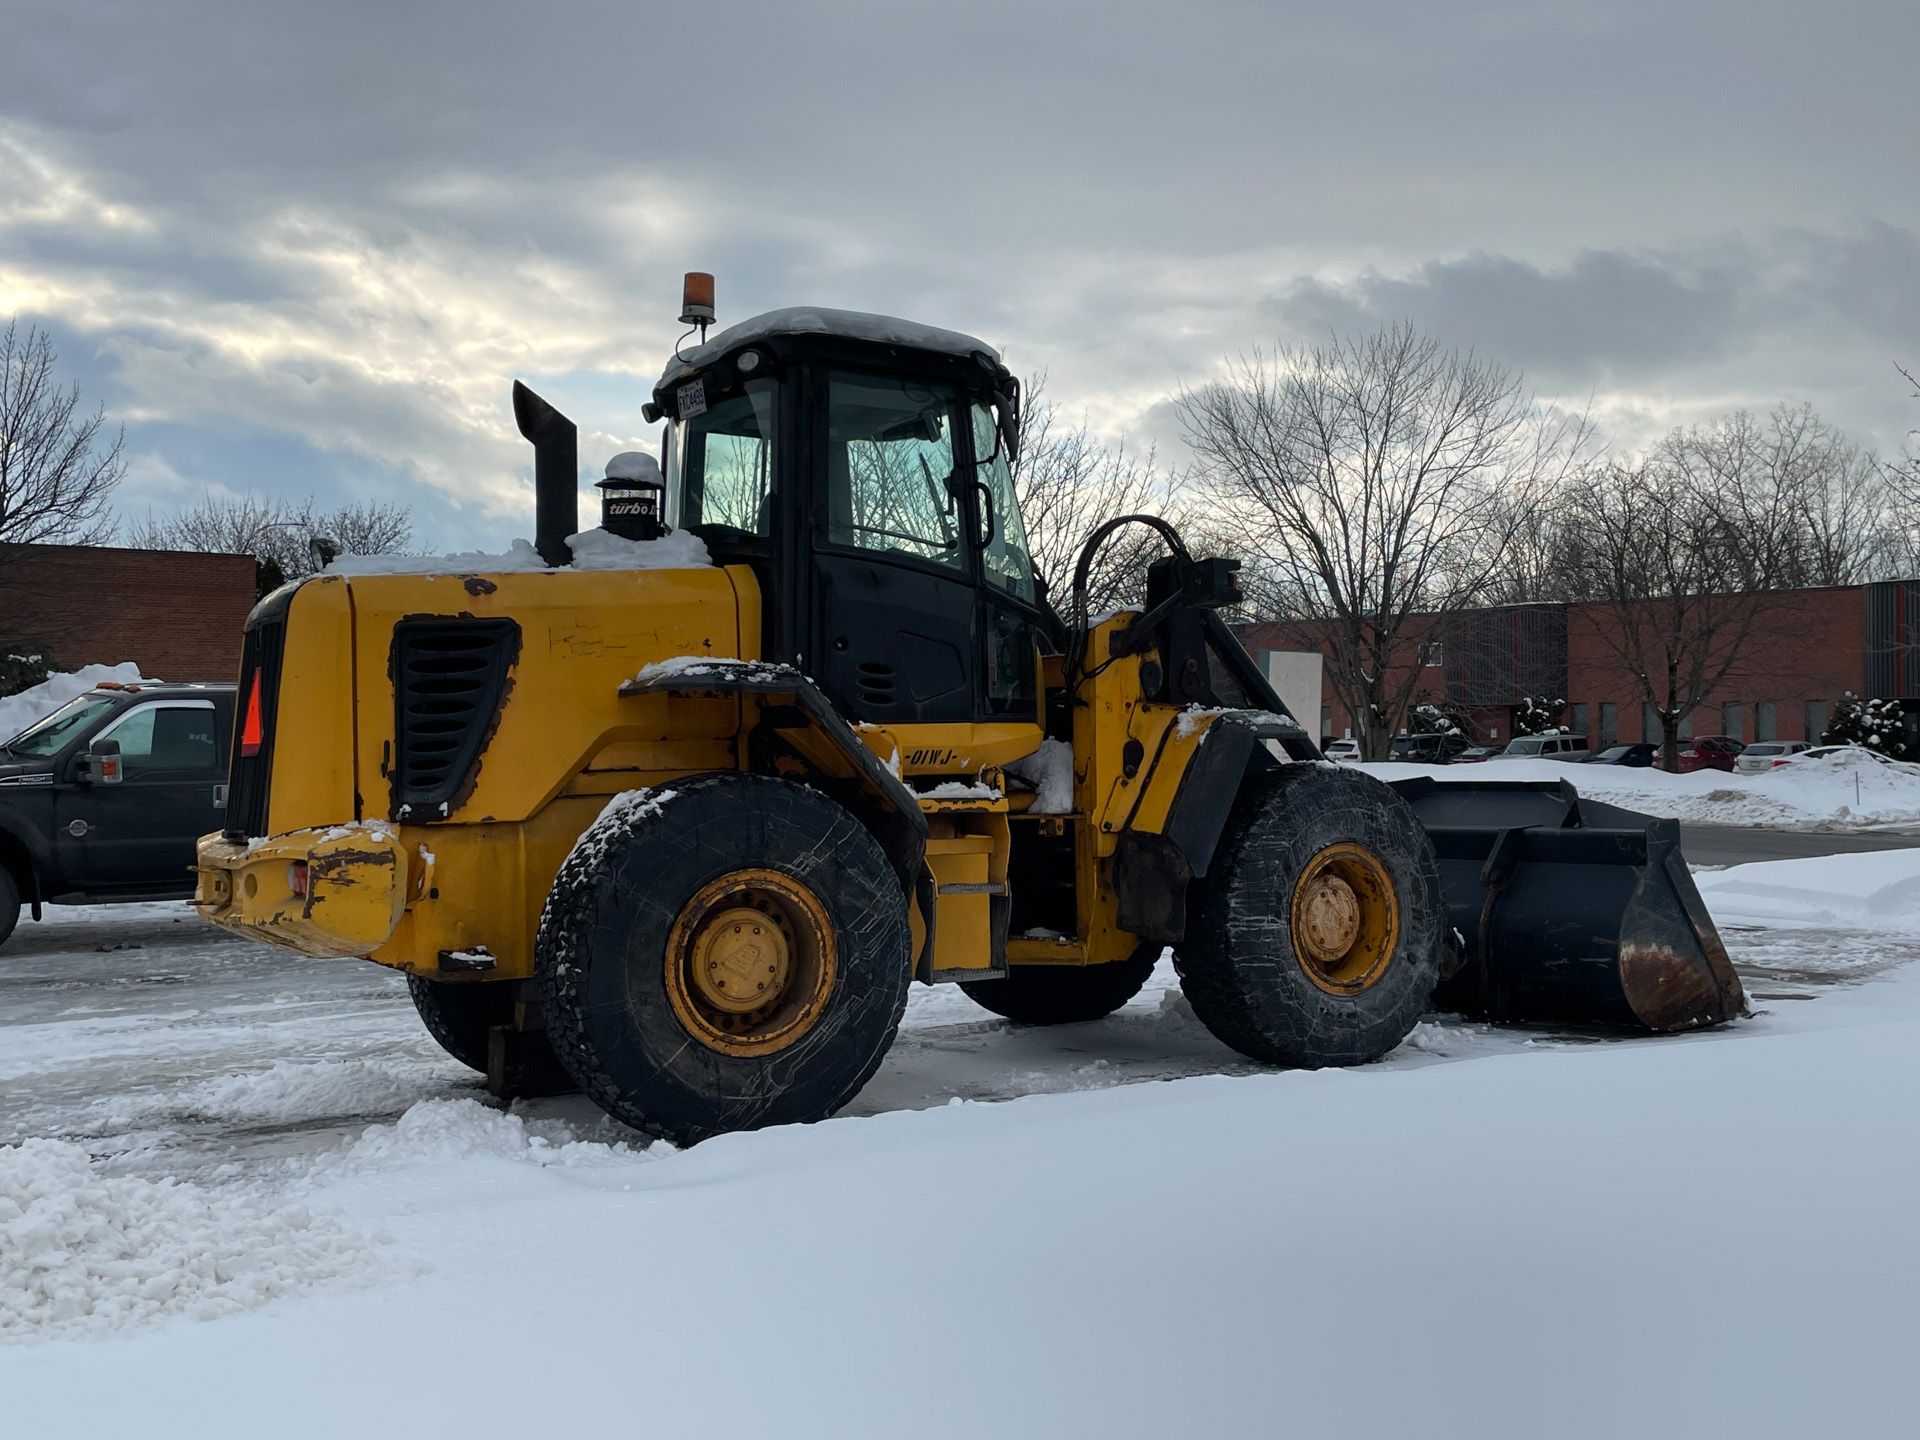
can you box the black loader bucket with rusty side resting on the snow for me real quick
[1392,778,1747,1031]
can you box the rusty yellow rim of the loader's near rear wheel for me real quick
[666,870,839,1056]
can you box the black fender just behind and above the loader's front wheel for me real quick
[1114,710,1306,945]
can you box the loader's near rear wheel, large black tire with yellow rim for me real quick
[536,774,912,1144]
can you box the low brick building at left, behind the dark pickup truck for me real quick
[0,545,253,682]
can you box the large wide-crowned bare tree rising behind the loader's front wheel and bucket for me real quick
[1179,324,1590,760]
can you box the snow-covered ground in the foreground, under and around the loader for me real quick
[0,851,1920,1436]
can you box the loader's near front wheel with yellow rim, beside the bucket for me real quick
[1173,764,1446,1069]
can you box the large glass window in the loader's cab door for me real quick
[828,374,966,570]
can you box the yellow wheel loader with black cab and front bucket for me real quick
[196,276,1743,1142]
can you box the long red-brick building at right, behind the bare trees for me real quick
[1242,580,1920,749]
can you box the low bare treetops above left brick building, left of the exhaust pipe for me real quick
[129,492,413,593]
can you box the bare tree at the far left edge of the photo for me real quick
[0,321,127,545]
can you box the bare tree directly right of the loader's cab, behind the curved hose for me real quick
[1014,372,1185,612]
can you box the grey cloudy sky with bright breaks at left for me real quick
[0,0,1920,549]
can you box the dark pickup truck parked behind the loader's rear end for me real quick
[0,684,234,943]
